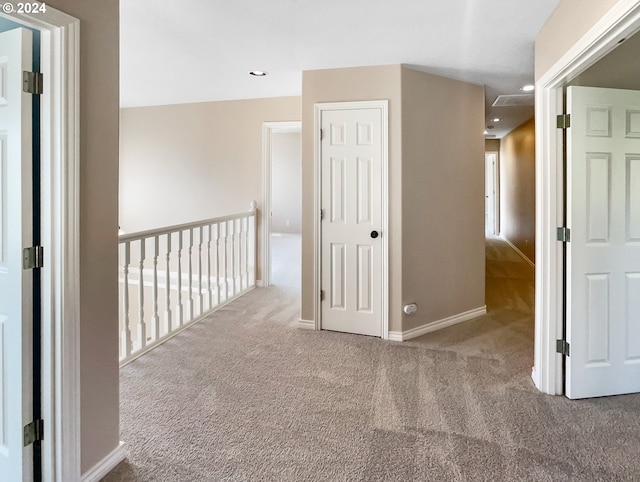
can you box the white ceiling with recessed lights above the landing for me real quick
[120,0,559,138]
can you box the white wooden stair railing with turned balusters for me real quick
[119,202,257,366]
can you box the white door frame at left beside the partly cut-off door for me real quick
[0,5,81,481]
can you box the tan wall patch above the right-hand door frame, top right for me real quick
[535,0,621,79]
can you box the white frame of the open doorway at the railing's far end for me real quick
[258,121,302,286]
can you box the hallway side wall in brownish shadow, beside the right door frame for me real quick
[500,118,536,262]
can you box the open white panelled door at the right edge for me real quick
[566,87,640,398]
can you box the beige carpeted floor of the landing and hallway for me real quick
[104,239,640,482]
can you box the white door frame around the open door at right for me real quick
[531,0,640,395]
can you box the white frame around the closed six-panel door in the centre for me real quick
[313,100,389,340]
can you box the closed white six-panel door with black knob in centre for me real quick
[320,108,387,336]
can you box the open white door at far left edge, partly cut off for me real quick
[0,28,33,481]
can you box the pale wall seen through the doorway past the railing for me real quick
[271,132,302,234]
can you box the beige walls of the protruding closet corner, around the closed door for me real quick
[302,65,484,331]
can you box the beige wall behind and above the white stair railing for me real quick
[119,97,300,279]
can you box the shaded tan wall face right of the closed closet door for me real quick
[402,68,485,331]
